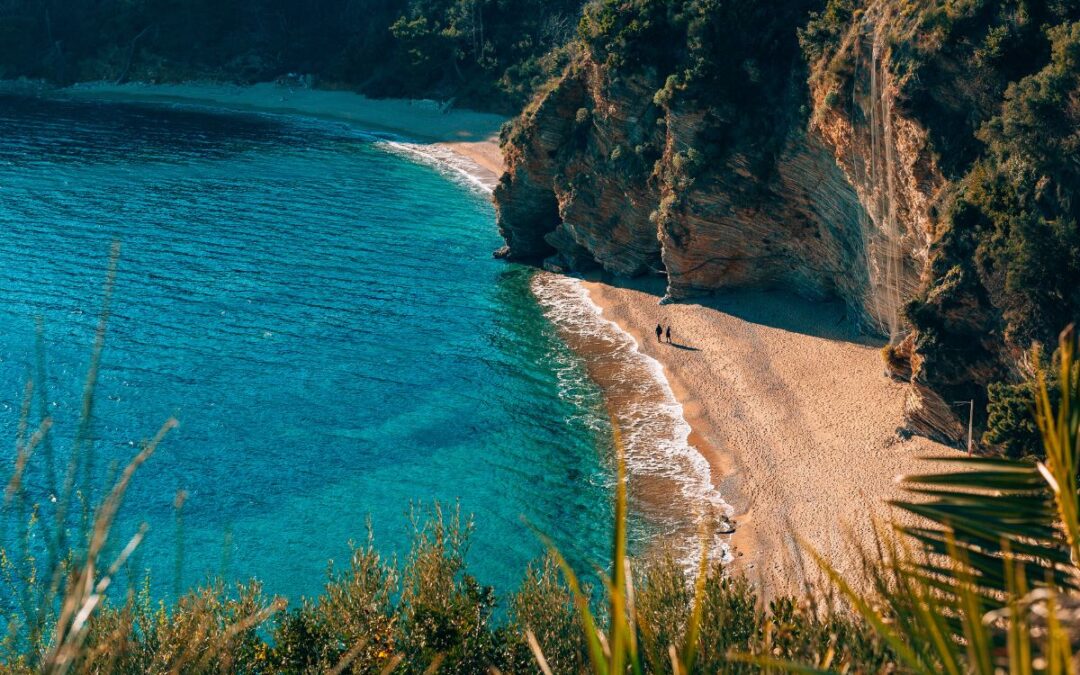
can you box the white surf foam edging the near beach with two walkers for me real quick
[532,272,733,570]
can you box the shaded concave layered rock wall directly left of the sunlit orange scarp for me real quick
[657,107,867,321]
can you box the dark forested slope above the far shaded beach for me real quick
[0,0,581,112]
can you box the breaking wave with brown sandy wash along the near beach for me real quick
[532,272,733,569]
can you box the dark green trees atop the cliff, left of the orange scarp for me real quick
[578,0,820,181]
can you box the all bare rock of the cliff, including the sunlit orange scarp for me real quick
[496,3,985,441]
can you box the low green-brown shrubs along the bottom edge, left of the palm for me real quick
[0,508,892,674]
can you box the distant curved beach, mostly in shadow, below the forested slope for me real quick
[51,82,505,184]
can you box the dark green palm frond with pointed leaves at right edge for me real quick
[890,327,1080,608]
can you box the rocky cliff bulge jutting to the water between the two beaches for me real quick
[495,60,662,276]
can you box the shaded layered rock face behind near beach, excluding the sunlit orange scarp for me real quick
[496,58,873,325]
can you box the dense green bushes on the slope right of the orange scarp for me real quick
[910,9,1080,451]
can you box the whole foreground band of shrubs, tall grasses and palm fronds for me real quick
[6,333,1080,675]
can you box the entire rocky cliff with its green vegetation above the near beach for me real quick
[496,0,1080,453]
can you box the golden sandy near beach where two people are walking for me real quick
[585,274,956,596]
